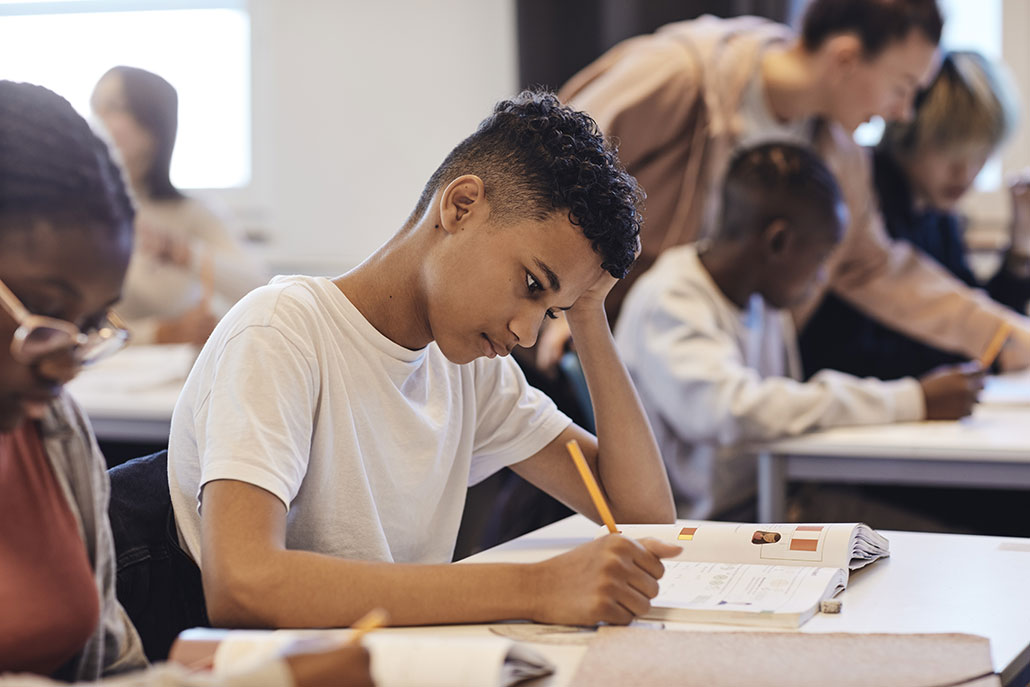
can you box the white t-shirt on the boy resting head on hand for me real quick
[168,276,571,563]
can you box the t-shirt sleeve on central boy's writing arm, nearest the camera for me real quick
[195,324,319,510]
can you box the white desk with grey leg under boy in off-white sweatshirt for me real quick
[758,404,1030,522]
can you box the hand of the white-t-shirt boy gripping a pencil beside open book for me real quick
[533,535,683,625]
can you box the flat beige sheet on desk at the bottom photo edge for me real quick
[572,627,1001,687]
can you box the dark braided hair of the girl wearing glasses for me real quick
[0,80,135,236]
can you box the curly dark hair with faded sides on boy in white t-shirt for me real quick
[408,91,644,278]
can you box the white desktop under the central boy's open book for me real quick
[465,515,1030,687]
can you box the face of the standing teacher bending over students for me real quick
[826,30,936,131]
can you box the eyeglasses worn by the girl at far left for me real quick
[0,280,130,366]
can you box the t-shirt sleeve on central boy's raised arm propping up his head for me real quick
[469,357,572,486]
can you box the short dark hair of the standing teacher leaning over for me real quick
[801,0,945,58]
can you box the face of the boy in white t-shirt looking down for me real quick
[426,206,604,365]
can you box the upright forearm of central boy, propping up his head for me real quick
[567,308,676,523]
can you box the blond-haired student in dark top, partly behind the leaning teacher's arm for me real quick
[800,51,1030,379]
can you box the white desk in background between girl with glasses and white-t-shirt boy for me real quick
[68,345,196,443]
